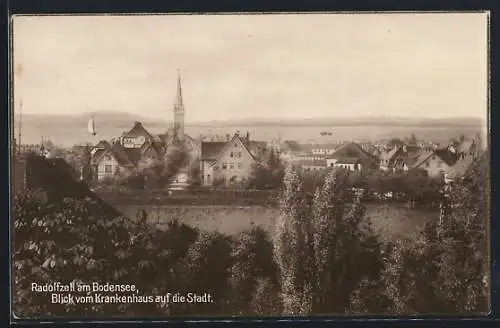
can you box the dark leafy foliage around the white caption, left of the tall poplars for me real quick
[13,193,276,318]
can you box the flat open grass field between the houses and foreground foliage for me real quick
[116,204,438,241]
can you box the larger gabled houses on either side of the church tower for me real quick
[91,122,269,185]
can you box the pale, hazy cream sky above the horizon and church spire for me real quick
[13,13,488,122]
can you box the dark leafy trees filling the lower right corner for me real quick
[376,154,488,315]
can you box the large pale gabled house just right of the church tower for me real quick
[201,133,267,186]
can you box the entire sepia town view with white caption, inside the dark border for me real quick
[9,12,491,320]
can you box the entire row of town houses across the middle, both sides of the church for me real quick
[88,117,479,186]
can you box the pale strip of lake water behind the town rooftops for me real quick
[16,122,477,147]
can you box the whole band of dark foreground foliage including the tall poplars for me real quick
[13,155,488,317]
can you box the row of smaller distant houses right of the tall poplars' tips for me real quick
[280,138,481,180]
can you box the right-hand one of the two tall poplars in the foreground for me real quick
[312,170,380,314]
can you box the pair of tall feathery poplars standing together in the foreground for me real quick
[275,168,380,315]
